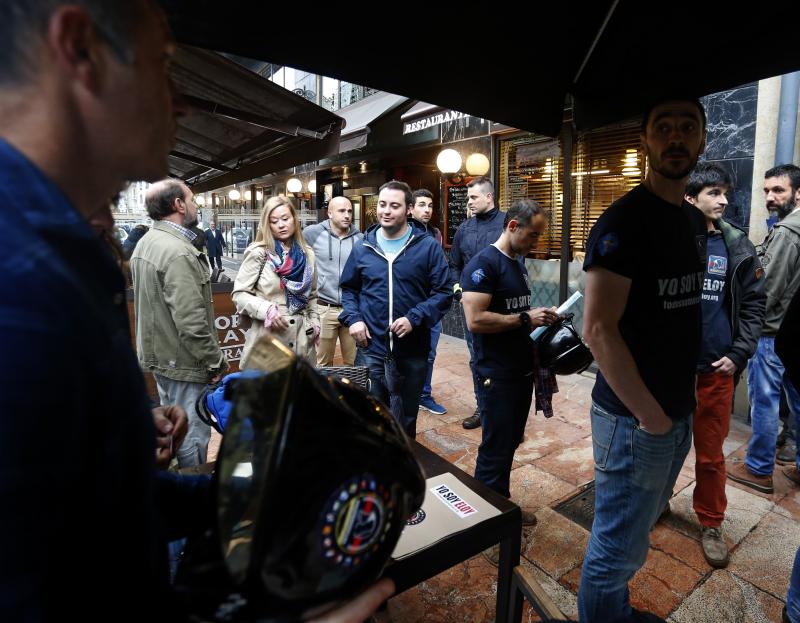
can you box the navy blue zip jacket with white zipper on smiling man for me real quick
[339,223,452,357]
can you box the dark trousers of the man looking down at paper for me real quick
[475,374,533,498]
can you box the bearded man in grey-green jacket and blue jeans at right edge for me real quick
[728,164,800,493]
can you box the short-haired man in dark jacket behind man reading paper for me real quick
[450,177,504,428]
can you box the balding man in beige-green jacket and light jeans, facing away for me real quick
[130,179,227,467]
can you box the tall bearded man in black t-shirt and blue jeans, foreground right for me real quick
[578,97,706,623]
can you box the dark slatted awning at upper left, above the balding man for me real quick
[169,46,344,192]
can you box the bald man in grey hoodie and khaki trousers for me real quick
[303,197,364,366]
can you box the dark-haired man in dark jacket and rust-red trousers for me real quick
[686,162,766,568]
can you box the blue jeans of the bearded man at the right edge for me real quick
[744,337,800,476]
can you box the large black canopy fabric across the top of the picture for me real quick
[162,0,800,136]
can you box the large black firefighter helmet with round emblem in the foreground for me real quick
[177,336,425,621]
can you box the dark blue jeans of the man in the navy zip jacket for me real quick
[356,348,428,439]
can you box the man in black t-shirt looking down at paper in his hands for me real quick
[461,199,558,508]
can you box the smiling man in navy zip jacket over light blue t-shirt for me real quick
[339,180,452,437]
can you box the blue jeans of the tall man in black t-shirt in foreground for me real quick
[578,404,692,623]
